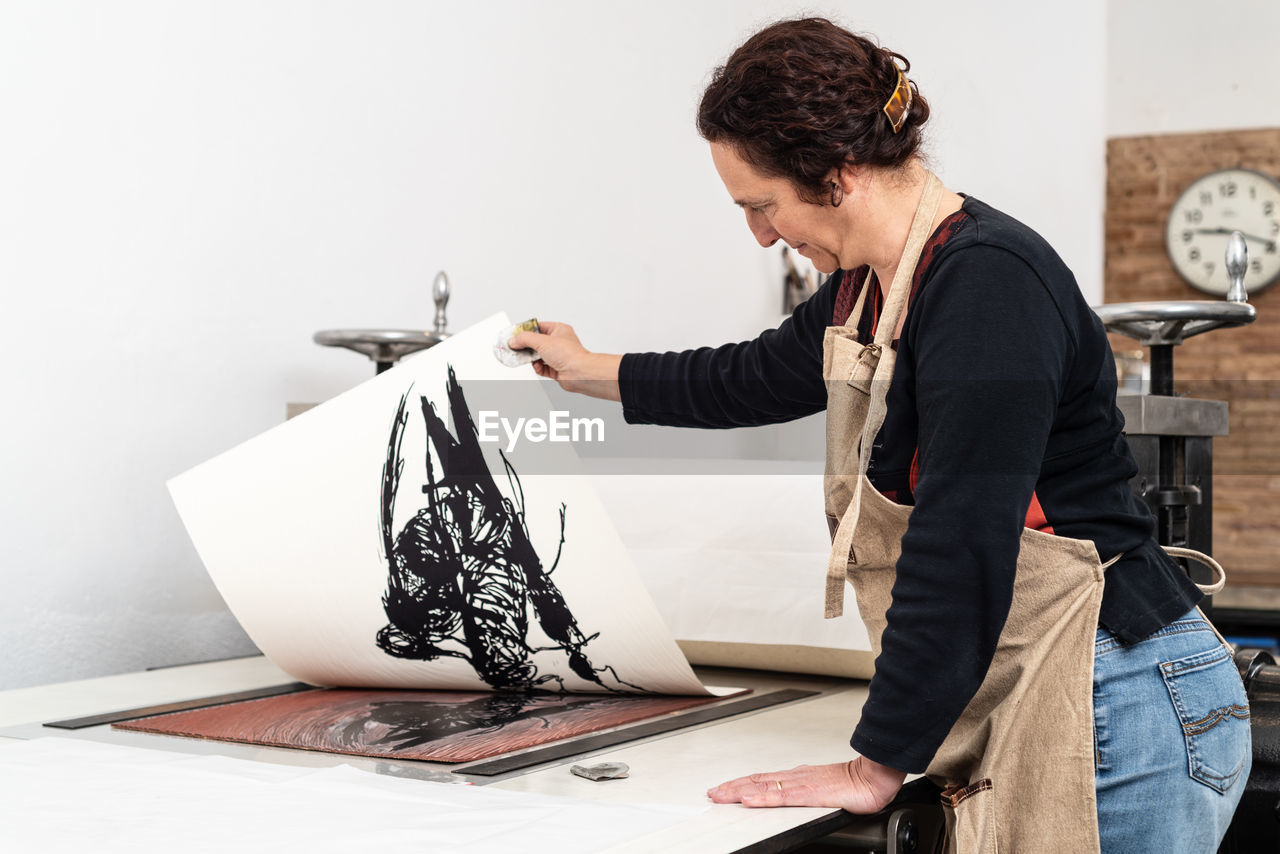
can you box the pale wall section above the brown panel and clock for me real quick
[1106,0,1280,137]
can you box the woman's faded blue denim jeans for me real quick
[1093,611,1253,854]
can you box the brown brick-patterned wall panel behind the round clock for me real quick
[1103,128,1280,586]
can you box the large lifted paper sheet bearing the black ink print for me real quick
[169,315,707,694]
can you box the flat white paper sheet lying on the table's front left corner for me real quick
[0,737,705,854]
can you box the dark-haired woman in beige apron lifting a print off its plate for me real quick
[511,19,1251,853]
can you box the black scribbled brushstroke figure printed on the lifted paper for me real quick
[378,365,644,691]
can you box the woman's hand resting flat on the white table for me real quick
[707,757,906,814]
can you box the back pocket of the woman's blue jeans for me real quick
[1160,645,1252,793]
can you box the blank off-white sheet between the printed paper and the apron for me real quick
[593,460,872,652]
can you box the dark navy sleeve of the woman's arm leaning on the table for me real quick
[850,245,1075,773]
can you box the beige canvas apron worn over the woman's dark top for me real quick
[823,173,1222,854]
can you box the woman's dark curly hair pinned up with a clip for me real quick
[698,18,929,205]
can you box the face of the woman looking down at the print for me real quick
[712,142,850,273]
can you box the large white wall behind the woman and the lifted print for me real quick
[0,0,1105,688]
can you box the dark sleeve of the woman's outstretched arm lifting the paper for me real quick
[618,275,840,428]
